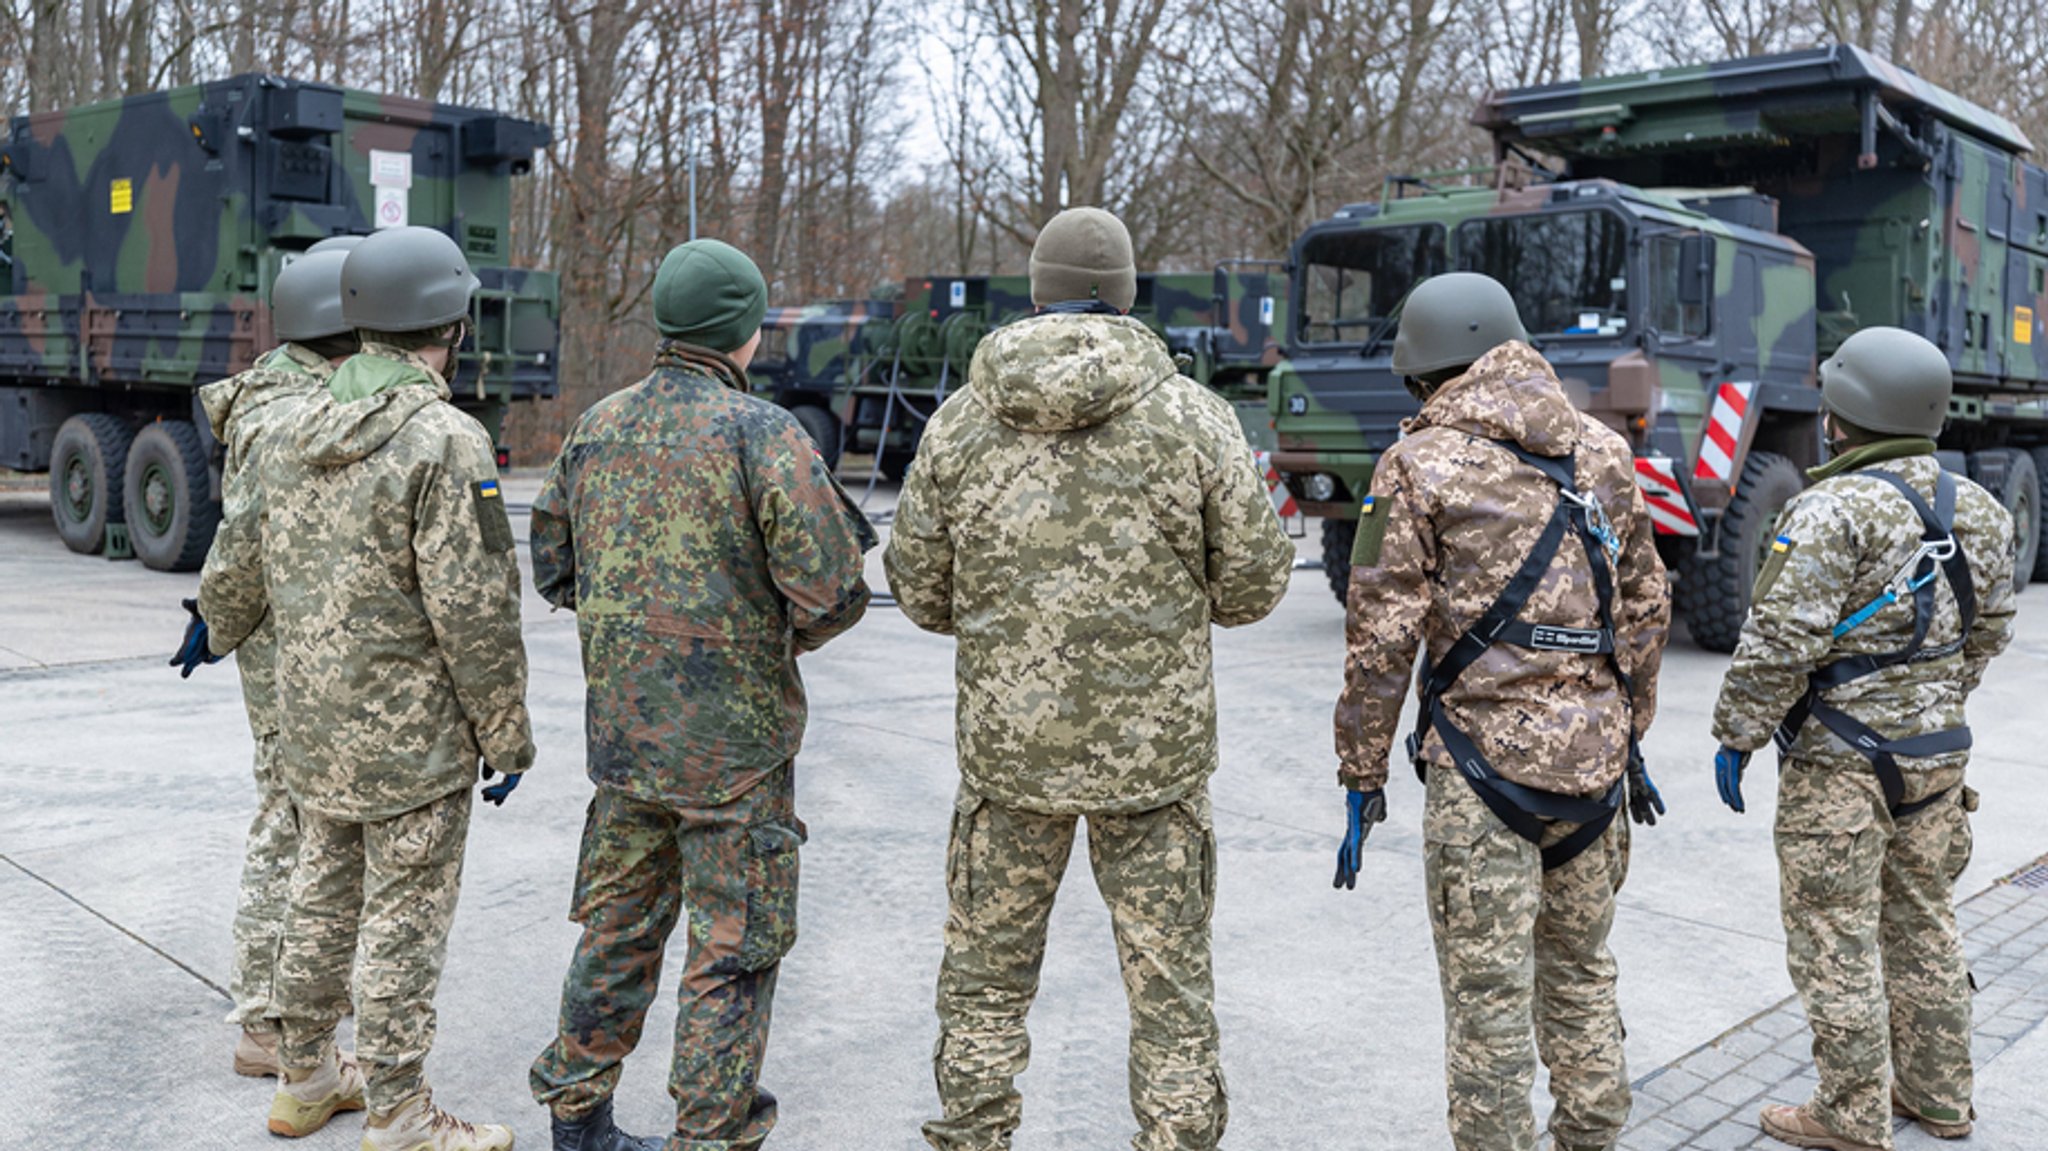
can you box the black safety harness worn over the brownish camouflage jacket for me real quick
[1407,440,1640,870]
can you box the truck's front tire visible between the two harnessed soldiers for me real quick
[1673,451,1806,651]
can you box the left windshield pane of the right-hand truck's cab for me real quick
[1294,223,1446,344]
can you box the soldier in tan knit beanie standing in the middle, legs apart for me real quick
[887,209,1294,1151]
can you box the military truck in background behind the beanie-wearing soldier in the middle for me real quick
[748,260,1286,477]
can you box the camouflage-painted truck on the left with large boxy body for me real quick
[0,76,559,571]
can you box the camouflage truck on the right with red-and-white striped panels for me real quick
[1270,47,2048,651]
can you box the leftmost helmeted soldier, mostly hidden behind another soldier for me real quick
[170,243,356,1077]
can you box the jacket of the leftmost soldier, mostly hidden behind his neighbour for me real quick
[199,344,334,737]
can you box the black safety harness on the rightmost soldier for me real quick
[1774,469,1976,819]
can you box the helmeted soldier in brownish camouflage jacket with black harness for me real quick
[1337,272,1671,1151]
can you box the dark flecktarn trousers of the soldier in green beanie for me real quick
[528,766,805,1151]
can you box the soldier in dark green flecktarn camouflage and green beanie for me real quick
[530,240,874,1151]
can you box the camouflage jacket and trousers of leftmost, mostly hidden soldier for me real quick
[199,335,334,1026]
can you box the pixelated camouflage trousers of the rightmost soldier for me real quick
[1776,760,1972,1147]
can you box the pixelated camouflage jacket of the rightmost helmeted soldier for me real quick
[1714,440,2017,801]
